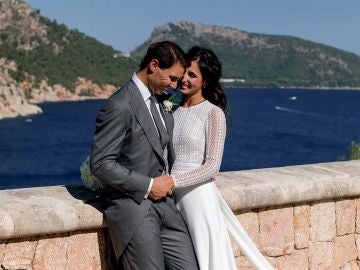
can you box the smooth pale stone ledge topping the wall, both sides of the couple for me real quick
[0,161,360,239]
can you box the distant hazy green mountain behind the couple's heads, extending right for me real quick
[131,21,360,88]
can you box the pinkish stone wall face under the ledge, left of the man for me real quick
[0,229,107,270]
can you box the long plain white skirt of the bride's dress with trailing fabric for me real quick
[174,182,274,270]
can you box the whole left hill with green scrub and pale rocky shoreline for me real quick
[0,0,137,119]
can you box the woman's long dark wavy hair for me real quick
[186,46,226,113]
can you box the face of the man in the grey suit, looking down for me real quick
[149,62,185,94]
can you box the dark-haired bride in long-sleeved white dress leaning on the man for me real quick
[171,47,273,270]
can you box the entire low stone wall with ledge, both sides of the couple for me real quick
[0,161,360,270]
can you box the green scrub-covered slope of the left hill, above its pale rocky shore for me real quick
[0,1,137,91]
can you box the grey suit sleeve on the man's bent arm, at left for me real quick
[90,99,151,204]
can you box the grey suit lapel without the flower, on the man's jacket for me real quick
[129,81,163,157]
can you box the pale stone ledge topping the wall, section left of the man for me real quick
[0,186,105,239]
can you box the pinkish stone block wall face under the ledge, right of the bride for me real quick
[233,197,360,270]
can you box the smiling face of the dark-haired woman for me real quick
[180,61,203,95]
